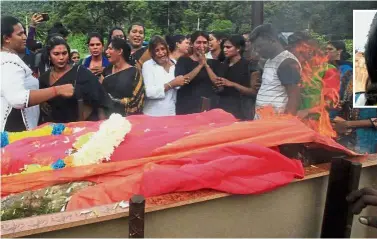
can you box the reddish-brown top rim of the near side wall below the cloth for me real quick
[1,154,377,237]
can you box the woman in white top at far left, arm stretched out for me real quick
[0,16,74,132]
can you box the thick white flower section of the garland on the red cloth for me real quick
[72,114,131,166]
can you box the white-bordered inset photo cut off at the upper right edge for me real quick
[353,10,377,108]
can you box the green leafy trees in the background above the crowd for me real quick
[1,0,360,57]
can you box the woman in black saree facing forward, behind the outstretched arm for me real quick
[39,36,109,123]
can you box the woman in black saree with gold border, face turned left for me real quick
[101,38,145,116]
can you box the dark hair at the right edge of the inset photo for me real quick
[365,17,377,105]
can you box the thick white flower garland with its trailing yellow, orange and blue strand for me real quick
[21,114,131,173]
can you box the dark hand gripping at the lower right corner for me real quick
[346,188,377,228]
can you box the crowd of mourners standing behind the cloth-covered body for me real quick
[1,14,377,153]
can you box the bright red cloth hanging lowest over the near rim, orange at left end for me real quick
[67,143,304,210]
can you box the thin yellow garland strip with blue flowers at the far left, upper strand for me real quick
[1,124,72,148]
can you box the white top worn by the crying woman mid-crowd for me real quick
[142,59,177,116]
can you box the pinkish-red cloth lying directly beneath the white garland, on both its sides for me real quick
[1,111,236,175]
